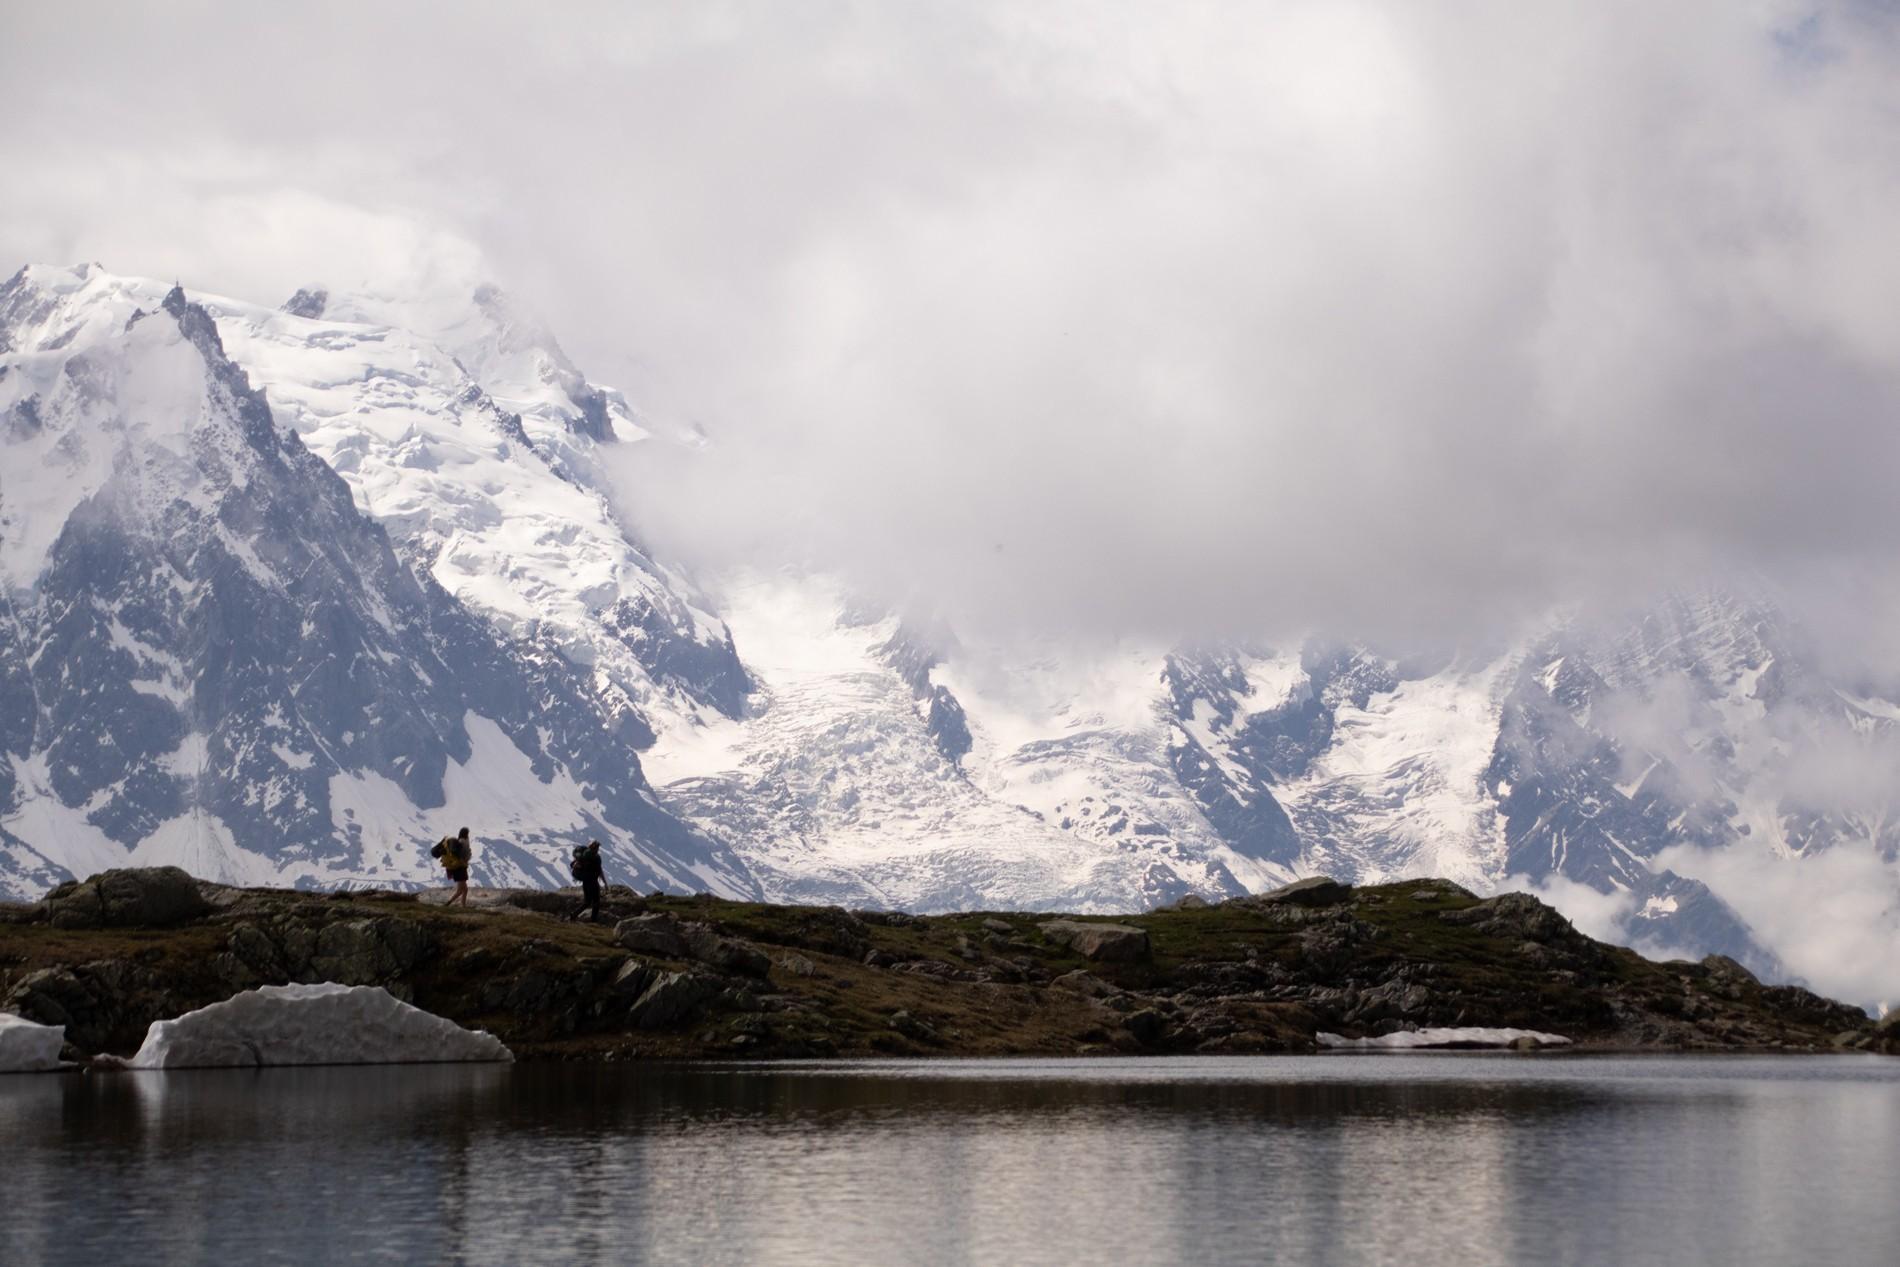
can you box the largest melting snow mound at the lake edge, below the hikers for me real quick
[127,982,515,1069]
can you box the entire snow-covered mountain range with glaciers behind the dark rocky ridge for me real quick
[0,268,1900,995]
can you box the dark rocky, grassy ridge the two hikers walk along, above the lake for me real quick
[0,868,1900,1058]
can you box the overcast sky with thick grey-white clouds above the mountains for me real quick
[0,0,1900,644]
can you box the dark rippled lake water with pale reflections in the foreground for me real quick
[0,1054,1900,1267]
